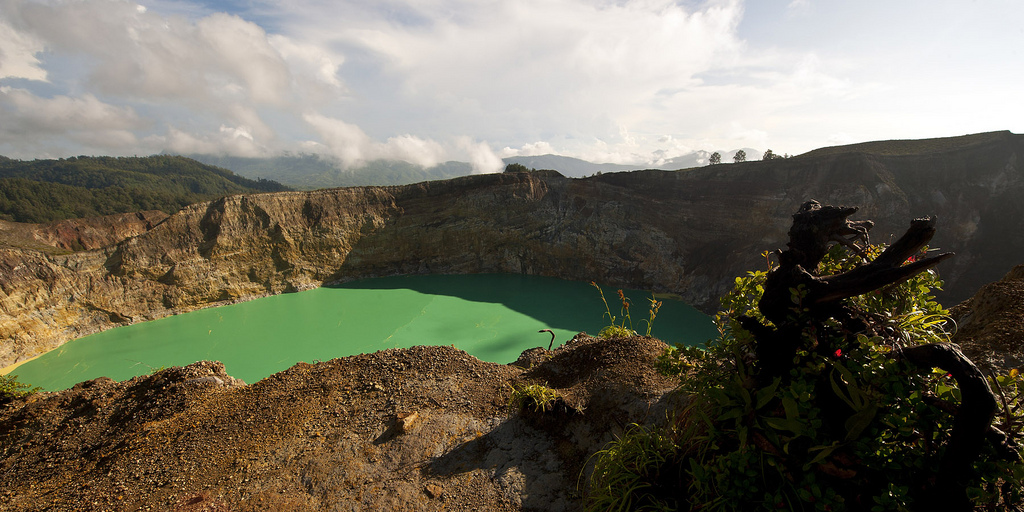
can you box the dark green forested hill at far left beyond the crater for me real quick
[0,156,289,222]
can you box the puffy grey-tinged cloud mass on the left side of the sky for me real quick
[0,0,343,155]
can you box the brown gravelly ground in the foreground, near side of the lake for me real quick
[0,335,678,511]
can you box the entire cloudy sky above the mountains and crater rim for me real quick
[0,0,1024,171]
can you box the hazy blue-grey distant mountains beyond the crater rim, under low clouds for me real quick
[188,147,761,190]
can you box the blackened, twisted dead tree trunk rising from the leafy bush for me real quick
[757,201,996,511]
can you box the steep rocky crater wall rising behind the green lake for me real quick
[0,132,1024,365]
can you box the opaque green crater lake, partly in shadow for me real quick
[12,274,716,390]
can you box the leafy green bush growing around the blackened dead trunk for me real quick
[589,246,1024,512]
